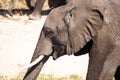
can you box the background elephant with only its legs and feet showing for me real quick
[8,0,67,20]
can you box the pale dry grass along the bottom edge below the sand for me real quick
[0,72,84,80]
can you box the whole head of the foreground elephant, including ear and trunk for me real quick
[24,0,103,80]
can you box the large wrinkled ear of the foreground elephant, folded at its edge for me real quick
[64,7,104,54]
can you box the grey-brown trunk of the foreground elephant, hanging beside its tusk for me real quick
[23,34,53,80]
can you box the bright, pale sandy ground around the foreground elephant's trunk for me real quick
[0,13,88,77]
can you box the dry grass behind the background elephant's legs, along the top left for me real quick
[0,0,49,20]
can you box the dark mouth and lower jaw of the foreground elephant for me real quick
[51,45,66,60]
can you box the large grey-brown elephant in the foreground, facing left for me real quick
[23,0,120,80]
